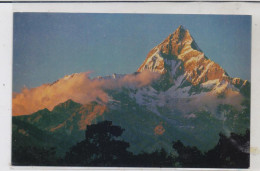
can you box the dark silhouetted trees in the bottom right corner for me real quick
[173,130,250,168]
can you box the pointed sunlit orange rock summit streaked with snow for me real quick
[137,25,229,85]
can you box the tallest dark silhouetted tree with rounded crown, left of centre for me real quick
[65,121,130,166]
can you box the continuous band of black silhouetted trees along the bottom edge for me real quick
[12,121,250,168]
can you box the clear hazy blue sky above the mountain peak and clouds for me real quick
[13,13,251,92]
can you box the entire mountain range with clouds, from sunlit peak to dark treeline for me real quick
[13,26,250,156]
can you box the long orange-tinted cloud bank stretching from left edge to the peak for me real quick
[13,71,159,116]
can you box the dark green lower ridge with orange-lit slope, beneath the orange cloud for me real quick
[13,100,106,156]
